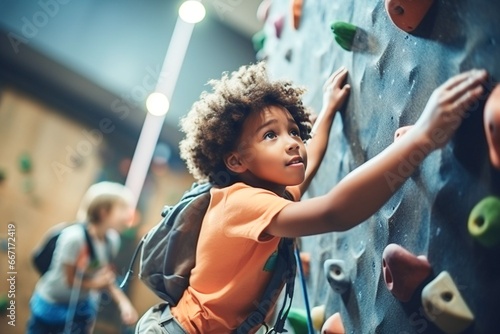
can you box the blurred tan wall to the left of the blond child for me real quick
[0,90,101,333]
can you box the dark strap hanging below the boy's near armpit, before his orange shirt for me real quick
[235,238,296,334]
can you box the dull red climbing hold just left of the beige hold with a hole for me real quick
[382,244,431,302]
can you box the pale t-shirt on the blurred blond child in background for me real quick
[35,224,120,304]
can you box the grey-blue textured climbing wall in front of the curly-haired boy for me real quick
[258,0,500,333]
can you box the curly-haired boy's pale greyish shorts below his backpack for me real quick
[135,303,188,334]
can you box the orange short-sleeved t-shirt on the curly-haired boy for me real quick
[172,182,291,334]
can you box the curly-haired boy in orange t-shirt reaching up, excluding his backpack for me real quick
[136,63,487,334]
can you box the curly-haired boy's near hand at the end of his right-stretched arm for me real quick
[414,69,488,148]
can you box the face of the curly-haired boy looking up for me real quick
[226,106,307,187]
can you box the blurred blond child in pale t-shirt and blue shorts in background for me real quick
[27,182,137,334]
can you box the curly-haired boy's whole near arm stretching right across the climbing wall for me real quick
[265,70,487,237]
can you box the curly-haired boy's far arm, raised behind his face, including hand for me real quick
[292,67,351,200]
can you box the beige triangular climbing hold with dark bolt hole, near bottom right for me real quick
[422,271,474,334]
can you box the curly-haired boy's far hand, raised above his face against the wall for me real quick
[323,66,351,112]
